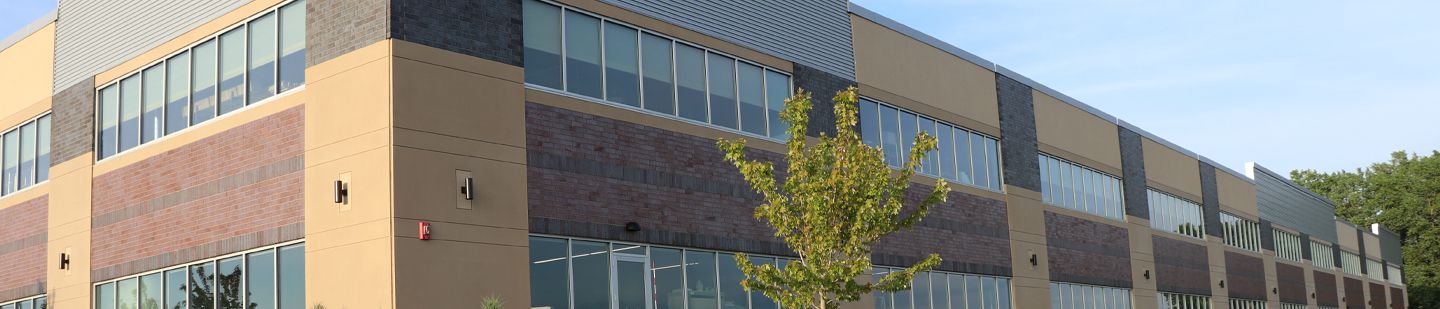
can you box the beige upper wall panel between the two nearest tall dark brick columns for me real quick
[1031,91,1120,171]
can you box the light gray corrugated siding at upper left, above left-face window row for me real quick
[55,0,249,93]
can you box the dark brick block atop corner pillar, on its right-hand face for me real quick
[390,0,524,66]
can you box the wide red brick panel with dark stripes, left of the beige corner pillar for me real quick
[91,106,305,280]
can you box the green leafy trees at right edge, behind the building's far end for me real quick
[1290,151,1440,308]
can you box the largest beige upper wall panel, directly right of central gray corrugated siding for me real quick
[850,16,996,129]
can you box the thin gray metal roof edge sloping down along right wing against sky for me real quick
[850,1,1254,184]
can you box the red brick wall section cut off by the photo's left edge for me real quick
[0,195,49,303]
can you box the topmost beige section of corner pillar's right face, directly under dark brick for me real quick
[395,57,526,147]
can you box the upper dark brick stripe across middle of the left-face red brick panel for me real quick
[91,155,305,229]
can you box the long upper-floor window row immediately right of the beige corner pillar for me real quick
[524,0,791,139]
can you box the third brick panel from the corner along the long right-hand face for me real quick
[1151,234,1211,295]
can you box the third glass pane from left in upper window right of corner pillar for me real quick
[605,23,639,108]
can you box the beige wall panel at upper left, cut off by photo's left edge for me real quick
[0,23,55,118]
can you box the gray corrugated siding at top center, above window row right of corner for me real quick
[605,0,855,79]
